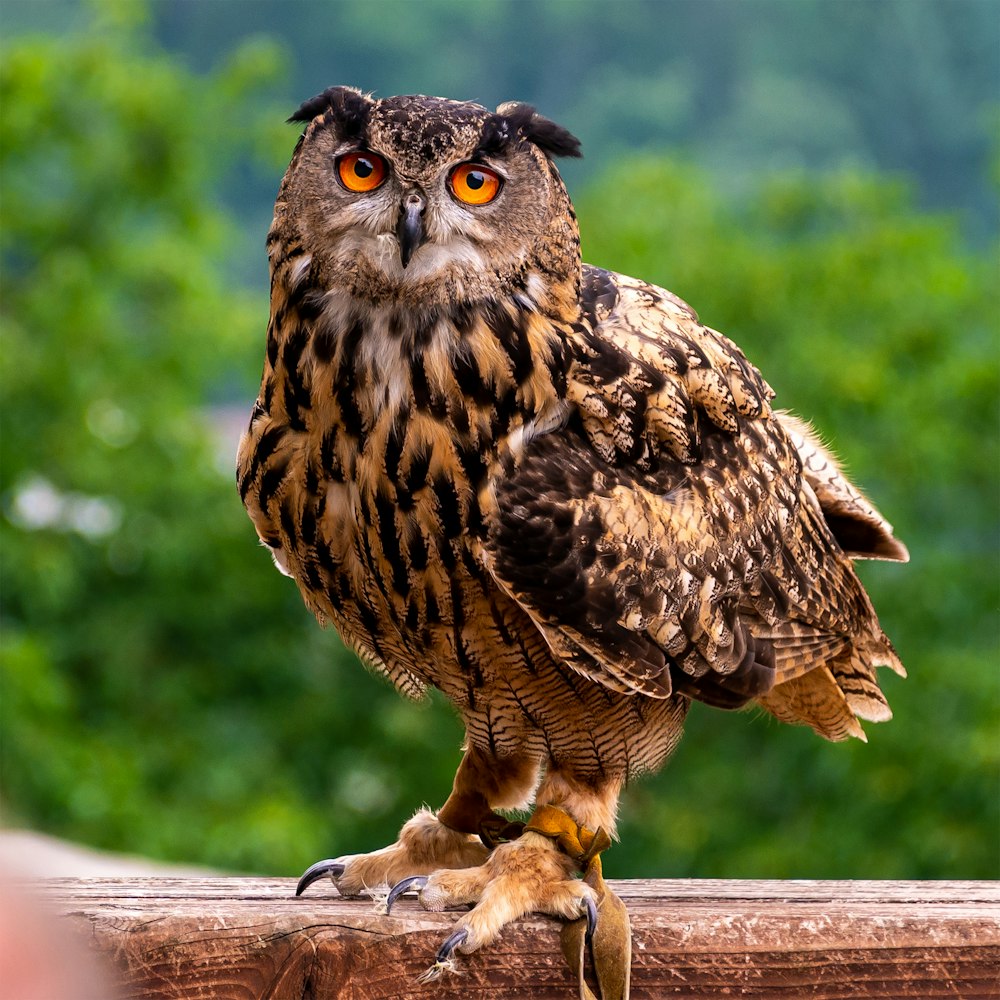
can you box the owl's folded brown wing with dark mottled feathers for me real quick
[481,273,908,720]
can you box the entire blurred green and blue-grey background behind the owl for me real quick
[0,0,1000,878]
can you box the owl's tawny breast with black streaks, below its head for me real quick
[241,278,569,700]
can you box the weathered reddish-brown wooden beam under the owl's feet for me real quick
[35,878,1000,1000]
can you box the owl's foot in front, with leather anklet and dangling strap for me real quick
[385,806,631,1000]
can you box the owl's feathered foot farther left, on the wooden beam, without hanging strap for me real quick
[295,809,488,897]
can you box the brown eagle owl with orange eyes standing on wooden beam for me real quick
[238,87,906,992]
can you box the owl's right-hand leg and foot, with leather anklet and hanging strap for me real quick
[387,768,629,997]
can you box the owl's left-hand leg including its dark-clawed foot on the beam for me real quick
[296,746,538,897]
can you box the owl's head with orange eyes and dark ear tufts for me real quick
[272,87,580,307]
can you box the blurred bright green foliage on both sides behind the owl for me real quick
[0,4,1000,878]
